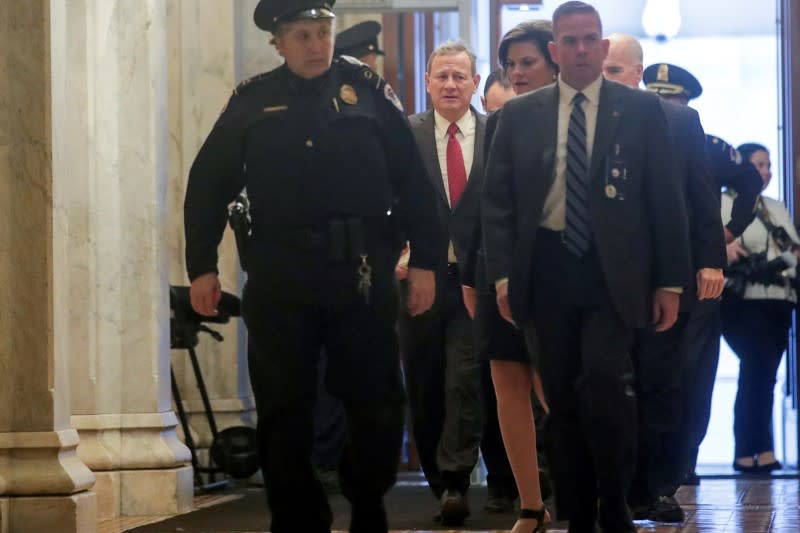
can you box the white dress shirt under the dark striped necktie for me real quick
[540,75,603,231]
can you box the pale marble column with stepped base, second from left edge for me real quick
[63,0,193,518]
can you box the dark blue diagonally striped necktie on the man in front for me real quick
[564,93,591,257]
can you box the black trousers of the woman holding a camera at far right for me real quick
[722,295,794,457]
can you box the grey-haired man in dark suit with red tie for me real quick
[399,43,485,526]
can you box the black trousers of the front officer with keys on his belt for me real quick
[242,280,404,533]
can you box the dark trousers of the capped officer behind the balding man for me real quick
[679,300,722,474]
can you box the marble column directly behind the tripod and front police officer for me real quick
[167,0,262,462]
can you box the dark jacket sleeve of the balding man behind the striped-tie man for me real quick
[661,100,727,310]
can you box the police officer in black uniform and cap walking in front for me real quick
[184,0,447,533]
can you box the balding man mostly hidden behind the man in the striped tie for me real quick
[603,34,725,522]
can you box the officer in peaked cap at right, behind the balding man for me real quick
[643,63,762,485]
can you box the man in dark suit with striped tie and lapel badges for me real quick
[481,2,691,533]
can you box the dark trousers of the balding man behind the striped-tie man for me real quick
[629,312,689,506]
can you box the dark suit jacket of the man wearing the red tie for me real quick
[408,107,486,276]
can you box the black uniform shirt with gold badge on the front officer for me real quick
[184,59,446,288]
